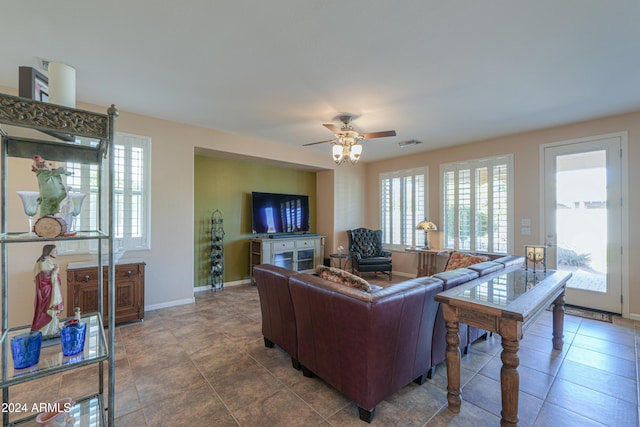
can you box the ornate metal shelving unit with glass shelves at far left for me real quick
[0,94,118,426]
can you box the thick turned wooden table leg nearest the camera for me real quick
[500,336,520,427]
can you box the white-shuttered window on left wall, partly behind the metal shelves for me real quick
[61,132,151,254]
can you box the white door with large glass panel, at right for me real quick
[544,137,622,313]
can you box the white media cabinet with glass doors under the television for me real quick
[249,234,324,280]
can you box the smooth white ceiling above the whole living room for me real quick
[0,0,640,161]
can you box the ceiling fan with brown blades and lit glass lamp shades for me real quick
[303,114,396,164]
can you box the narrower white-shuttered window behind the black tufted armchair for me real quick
[380,168,427,250]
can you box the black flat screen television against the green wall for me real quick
[251,192,309,234]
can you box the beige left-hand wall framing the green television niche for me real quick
[0,86,335,326]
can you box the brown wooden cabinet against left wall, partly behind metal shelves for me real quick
[65,261,145,323]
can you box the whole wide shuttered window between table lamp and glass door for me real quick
[440,155,513,253]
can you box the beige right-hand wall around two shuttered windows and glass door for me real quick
[366,112,640,319]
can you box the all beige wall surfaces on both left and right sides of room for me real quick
[0,83,640,325]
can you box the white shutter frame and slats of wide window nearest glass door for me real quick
[440,153,515,253]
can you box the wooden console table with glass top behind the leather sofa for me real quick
[435,269,571,426]
